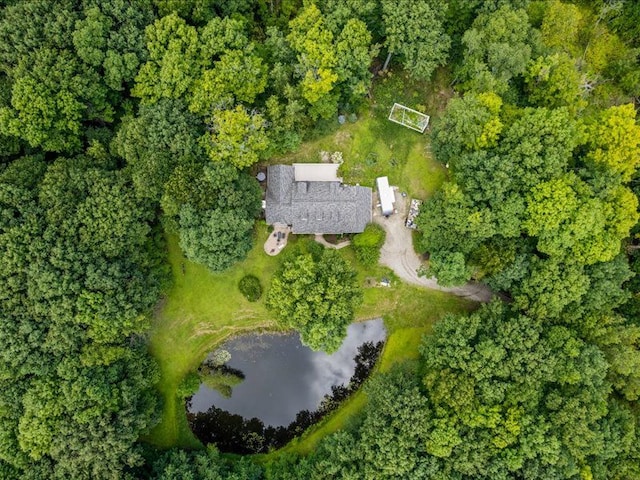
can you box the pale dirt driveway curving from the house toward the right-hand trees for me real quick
[373,189,493,302]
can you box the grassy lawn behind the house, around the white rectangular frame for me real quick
[270,67,451,199]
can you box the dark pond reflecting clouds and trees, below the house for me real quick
[187,319,386,453]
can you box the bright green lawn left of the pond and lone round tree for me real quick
[148,224,281,447]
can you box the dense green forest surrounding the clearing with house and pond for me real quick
[0,0,640,480]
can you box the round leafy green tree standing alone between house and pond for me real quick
[267,250,362,352]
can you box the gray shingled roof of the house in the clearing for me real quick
[265,165,372,234]
